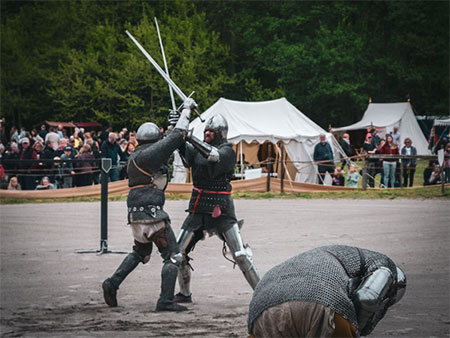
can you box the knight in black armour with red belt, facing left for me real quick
[175,114,259,303]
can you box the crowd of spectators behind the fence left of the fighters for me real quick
[0,121,137,190]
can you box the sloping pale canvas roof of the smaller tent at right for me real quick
[334,102,412,131]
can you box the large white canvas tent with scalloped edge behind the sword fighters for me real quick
[173,98,343,183]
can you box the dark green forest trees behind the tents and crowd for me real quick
[0,0,450,133]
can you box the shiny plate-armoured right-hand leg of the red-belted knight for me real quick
[223,223,260,290]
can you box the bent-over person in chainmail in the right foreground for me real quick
[248,245,406,338]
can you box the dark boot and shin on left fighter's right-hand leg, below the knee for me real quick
[156,261,187,312]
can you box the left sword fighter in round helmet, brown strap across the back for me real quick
[102,99,196,311]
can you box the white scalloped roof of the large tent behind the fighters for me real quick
[190,97,328,143]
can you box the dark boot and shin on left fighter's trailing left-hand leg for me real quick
[102,251,141,307]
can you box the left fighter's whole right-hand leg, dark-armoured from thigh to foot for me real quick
[154,225,187,312]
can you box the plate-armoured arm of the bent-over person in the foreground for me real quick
[353,267,394,336]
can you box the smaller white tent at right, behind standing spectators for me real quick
[334,102,430,155]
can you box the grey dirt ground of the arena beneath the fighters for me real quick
[0,199,450,337]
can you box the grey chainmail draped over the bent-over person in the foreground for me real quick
[248,245,396,332]
